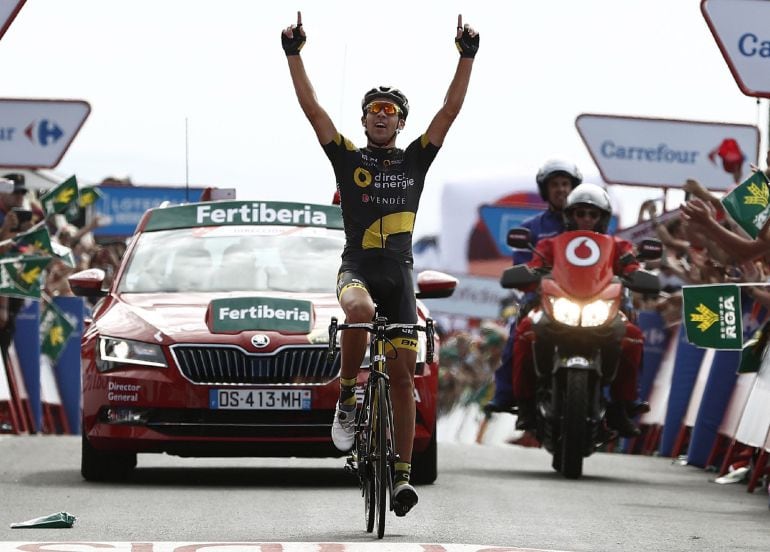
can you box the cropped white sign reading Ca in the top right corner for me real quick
[701,0,770,98]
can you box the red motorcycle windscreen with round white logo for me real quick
[551,231,615,298]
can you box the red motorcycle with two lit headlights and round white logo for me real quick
[500,228,662,479]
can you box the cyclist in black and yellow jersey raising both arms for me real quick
[281,12,479,516]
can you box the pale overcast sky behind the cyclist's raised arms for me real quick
[0,0,767,235]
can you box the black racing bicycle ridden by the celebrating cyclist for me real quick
[328,316,433,539]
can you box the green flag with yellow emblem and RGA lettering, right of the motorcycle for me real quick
[682,284,743,351]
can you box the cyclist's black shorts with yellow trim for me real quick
[337,257,417,351]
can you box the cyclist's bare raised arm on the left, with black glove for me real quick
[281,12,337,145]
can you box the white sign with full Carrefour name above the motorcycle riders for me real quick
[575,114,759,190]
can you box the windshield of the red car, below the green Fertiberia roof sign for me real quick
[118,226,344,293]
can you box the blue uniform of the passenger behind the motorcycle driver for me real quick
[492,209,564,406]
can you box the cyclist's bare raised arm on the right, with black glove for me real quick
[426,14,479,146]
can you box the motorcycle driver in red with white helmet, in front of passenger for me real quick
[513,183,644,437]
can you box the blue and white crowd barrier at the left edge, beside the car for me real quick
[0,297,86,434]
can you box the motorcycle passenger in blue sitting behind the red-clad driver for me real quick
[484,159,583,418]
